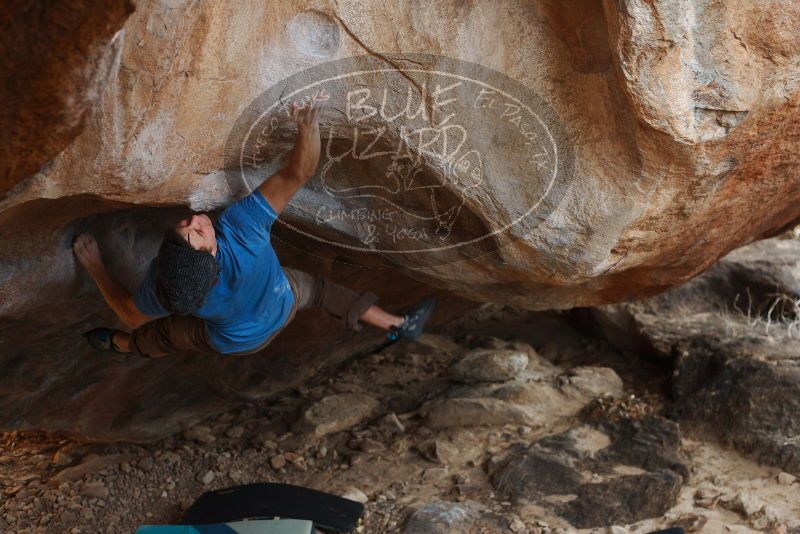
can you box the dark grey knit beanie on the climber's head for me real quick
[155,240,220,315]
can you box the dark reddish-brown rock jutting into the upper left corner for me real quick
[0,0,133,199]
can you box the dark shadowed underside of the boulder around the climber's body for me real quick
[0,203,474,442]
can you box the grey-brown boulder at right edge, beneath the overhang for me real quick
[596,239,800,474]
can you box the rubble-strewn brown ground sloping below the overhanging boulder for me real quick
[0,307,800,534]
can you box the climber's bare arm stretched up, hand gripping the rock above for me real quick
[258,104,321,214]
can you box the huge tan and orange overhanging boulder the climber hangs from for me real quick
[0,0,800,437]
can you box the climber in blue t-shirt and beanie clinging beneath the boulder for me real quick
[73,103,434,358]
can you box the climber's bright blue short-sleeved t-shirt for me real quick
[133,190,294,353]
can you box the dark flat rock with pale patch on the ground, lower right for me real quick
[490,417,689,528]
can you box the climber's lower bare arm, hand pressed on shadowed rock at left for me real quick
[72,234,153,330]
